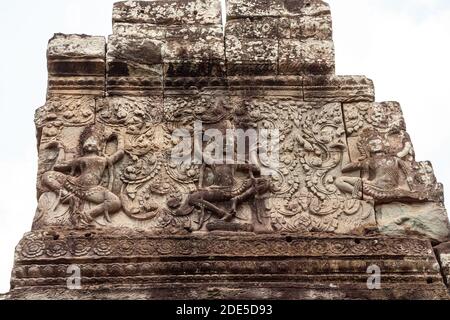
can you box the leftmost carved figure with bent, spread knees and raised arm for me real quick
[42,126,124,225]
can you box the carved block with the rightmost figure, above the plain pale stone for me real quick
[339,102,443,204]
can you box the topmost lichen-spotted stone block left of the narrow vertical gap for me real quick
[113,0,222,25]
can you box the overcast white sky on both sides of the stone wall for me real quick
[0,0,450,292]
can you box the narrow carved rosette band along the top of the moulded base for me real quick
[16,232,433,263]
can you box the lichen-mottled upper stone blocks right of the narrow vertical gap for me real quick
[225,1,334,75]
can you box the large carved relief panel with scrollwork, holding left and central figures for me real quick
[35,91,384,233]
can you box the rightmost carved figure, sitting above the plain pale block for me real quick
[336,130,427,203]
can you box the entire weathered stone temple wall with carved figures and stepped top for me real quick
[8,0,450,299]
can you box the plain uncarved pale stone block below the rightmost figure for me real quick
[376,202,450,243]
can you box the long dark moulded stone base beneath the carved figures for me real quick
[7,230,448,299]
